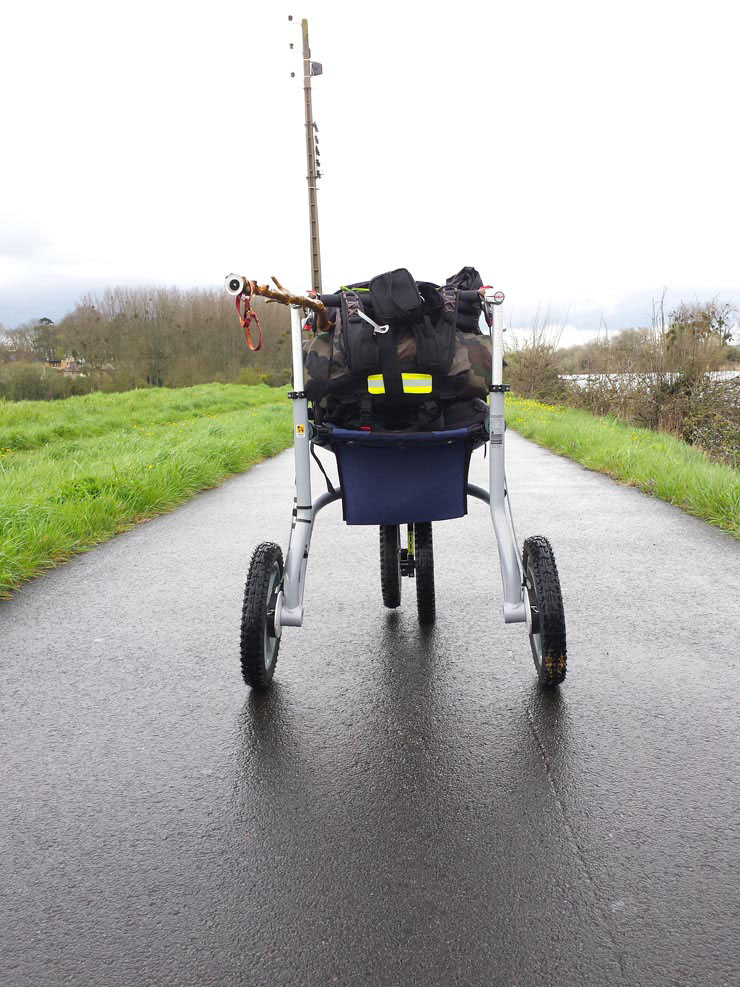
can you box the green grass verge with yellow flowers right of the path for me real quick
[506,396,740,538]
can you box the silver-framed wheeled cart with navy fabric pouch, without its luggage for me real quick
[226,275,566,689]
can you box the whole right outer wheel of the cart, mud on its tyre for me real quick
[522,535,567,688]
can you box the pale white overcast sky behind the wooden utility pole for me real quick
[0,0,740,342]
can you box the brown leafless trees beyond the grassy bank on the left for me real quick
[0,287,290,400]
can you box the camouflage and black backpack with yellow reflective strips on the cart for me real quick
[304,269,491,430]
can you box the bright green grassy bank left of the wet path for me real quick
[0,384,291,596]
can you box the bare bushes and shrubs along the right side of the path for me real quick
[506,300,740,468]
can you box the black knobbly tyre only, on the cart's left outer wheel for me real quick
[240,541,283,689]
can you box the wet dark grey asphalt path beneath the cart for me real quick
[0,434,740,987]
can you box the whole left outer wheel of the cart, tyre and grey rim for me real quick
[241,541,283,689]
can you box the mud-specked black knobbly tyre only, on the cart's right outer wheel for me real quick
[522,535,568,689]
